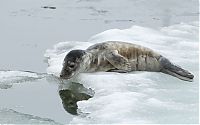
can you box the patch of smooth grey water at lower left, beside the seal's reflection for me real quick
[1,80,69,124]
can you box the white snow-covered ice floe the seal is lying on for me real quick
[45,22,199,124]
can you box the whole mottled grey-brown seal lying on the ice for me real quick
[60,41,194,81]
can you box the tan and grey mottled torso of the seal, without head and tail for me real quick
[86,42,161,71]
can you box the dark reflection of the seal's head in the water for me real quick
[59,82,94,115]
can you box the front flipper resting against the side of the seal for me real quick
[105,50,131,72]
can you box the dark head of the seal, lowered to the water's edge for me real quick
[60,50,86,79]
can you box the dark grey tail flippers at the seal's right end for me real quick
[159,57,194,82]
